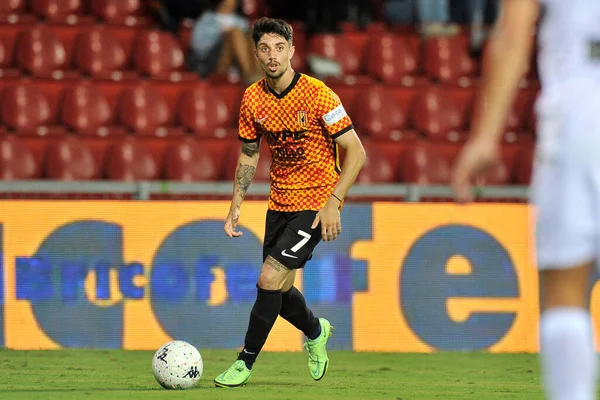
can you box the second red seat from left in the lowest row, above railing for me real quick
[44,136,100,181]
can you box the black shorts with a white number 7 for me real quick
[263,210,321,269]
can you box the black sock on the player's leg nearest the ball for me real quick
[238,285,281,369]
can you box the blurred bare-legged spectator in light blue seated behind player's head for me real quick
[188,0,262,84]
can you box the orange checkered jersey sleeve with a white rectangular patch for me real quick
[316,86,354,139]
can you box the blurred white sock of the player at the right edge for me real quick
[540,307,597,400]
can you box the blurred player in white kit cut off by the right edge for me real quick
[453,0,600,400]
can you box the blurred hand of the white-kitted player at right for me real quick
[451,137,500,203]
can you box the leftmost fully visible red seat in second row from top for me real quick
[16,25,77,79]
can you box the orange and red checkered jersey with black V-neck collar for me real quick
[239,73,353,212]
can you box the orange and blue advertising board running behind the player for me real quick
[0,201,576,352]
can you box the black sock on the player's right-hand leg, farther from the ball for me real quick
[279,286,321,339]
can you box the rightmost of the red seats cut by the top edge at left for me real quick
[90,0,152,26]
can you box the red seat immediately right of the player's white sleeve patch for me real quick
[354,85,406,139]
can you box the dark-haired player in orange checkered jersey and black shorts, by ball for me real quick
[214,18,365,387]
